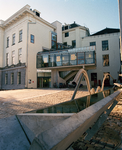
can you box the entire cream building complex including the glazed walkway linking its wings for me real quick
[0,5,120,89]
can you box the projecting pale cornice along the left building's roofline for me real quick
[1,5,56,29]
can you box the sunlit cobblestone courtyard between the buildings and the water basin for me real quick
[0,89,88,119]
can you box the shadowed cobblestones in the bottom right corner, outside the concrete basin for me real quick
[73,93,122,150]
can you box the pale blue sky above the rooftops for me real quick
[0,0,120,34]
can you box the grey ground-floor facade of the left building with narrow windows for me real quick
[0,64,26,89]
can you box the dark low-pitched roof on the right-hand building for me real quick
[91,28,120,36]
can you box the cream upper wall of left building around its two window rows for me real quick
[3,17,27,67]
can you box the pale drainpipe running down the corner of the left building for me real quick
[25,22,36,88]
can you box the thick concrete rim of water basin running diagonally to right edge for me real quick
[18,90,122,150]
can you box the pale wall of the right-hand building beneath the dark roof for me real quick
[81,33,120,83]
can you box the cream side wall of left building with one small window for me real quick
[26,15,54,88]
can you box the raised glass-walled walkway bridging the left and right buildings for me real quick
[37,46,96,69]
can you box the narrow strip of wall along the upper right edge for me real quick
[118,0,122,60]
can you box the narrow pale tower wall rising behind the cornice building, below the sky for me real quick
[52,21,62,43]
